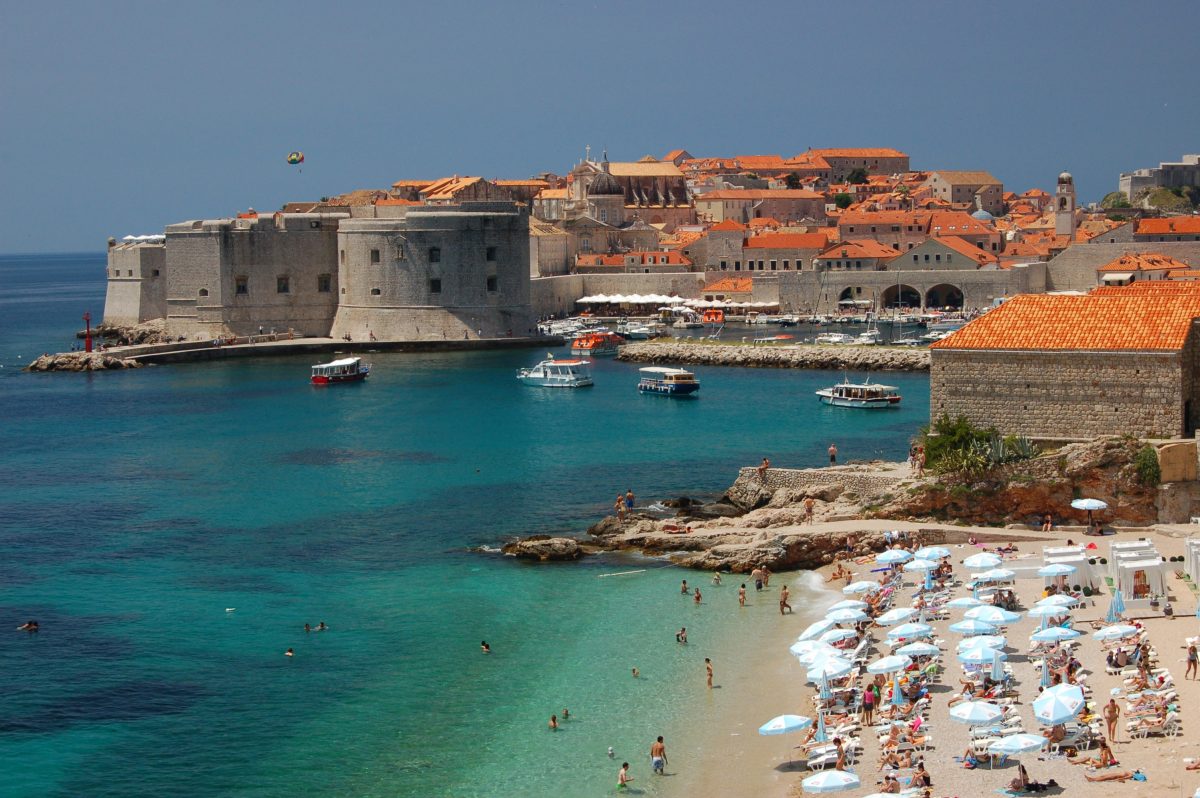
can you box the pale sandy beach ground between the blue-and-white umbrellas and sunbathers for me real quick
[659,522,1200,798]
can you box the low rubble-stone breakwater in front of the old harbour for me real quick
[618,341,929,371]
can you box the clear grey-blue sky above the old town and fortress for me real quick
[0,0,1200,252]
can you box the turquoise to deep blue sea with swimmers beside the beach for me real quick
[0,253,929,798]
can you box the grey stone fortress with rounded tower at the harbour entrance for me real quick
[104,202,535,341]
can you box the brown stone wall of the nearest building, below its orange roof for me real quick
[929,348,1180,438]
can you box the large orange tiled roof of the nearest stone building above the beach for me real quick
[931,286,1200,352]
